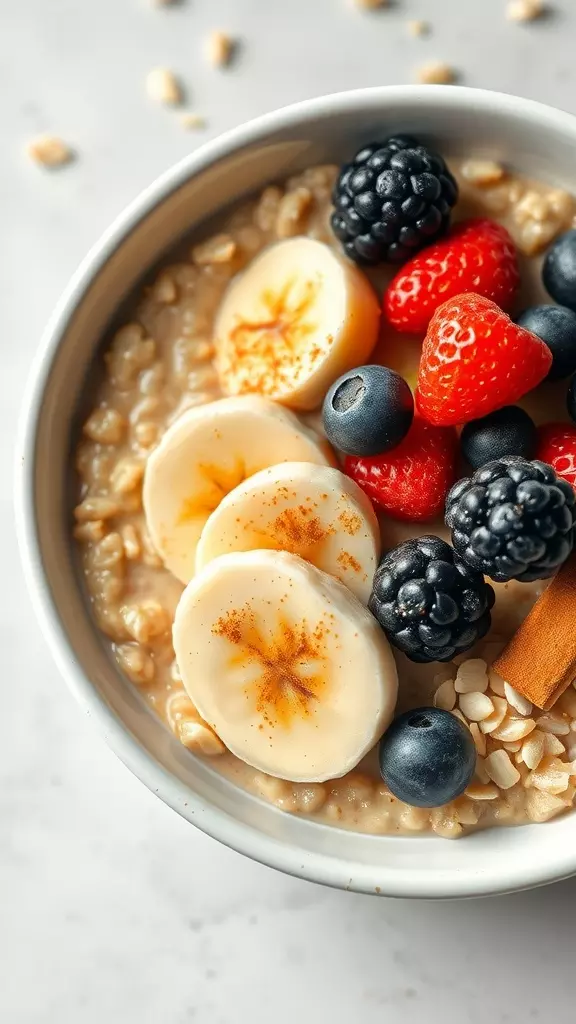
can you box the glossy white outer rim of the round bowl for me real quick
[14,85,576,899]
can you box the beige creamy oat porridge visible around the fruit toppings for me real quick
[75,160,576,838]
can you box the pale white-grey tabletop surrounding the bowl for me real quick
[0,0,576,1024]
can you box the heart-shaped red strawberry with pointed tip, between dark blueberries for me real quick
[416,294,552,427]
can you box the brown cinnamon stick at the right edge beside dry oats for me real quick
[494,555,576,711]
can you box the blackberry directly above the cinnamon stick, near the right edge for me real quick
[446,456,576,583]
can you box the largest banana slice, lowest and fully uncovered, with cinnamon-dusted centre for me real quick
[173,551,398,782]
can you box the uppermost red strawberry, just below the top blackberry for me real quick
[384,218,520,334]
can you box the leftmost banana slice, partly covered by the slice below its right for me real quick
[142,395,334,583]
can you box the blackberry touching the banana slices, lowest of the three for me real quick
[369,537,494,662]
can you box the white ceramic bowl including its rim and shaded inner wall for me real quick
[16,86,576,897]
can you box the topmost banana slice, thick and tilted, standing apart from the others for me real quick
[214,238,380,410]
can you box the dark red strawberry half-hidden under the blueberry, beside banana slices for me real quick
[344,417,458,522]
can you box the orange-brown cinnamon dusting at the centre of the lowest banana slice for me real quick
[211,603,330,728]
